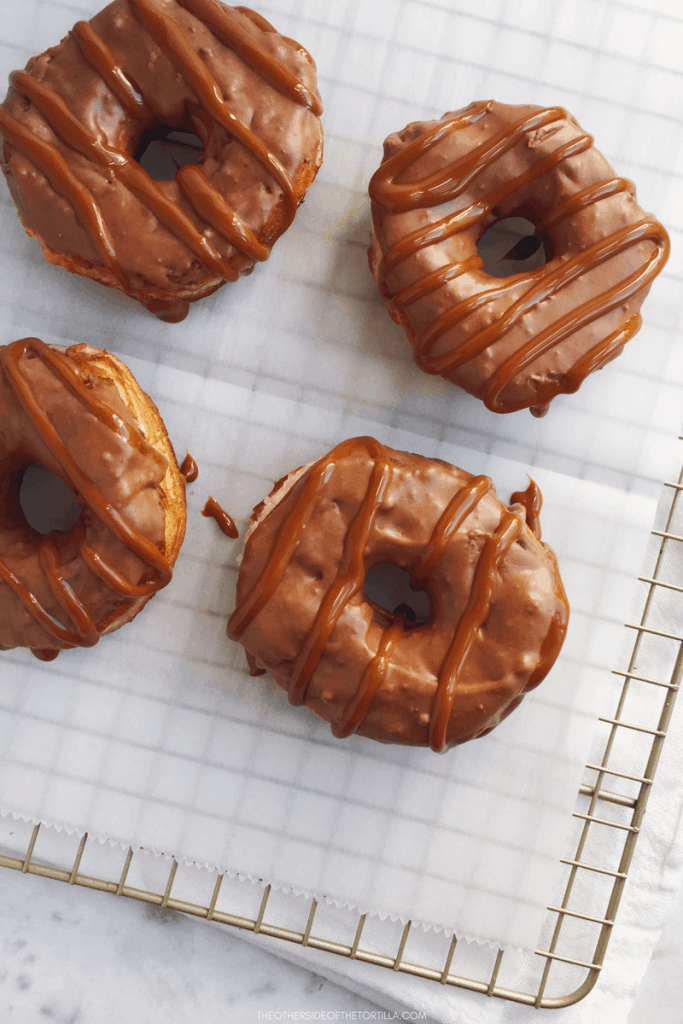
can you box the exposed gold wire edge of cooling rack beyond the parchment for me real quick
[0,437,683,1009]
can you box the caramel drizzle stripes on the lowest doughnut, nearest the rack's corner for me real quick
[227,437,523,751]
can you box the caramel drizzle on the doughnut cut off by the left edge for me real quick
[0,338,172,660]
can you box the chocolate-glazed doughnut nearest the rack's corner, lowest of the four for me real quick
[227,437,568,752]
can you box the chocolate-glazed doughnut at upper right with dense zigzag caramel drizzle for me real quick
[369,100,669,416]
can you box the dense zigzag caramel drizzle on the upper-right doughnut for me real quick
[370,102,669,412]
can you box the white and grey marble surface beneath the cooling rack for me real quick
[0,856,683,1024]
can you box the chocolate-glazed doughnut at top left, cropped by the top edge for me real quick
[0,0,323,323]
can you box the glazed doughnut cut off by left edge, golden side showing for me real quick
[0,338,185,660]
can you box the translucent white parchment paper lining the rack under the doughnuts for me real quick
[0,0,683,966]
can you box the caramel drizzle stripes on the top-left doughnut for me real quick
[0,0,321,296]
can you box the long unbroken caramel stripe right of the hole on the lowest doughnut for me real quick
[429,509,524,753]
